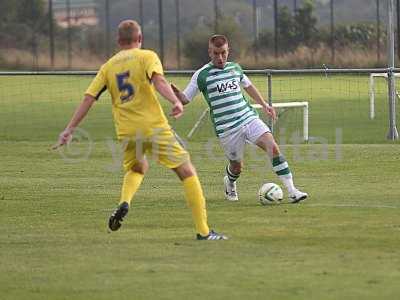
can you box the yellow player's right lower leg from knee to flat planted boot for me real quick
[173,162,228,240]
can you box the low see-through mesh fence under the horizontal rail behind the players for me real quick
[0,69,400,144]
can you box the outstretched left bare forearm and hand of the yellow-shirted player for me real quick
[53,94,96,149]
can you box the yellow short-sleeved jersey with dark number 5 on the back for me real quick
[86,48,170,139]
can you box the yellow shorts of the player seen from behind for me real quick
[122,129,190,171]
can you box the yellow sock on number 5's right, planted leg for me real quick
[183,176,210,236]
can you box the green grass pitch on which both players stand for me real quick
[0,77,400,300]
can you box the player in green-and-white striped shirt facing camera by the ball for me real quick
[172,35,308,203]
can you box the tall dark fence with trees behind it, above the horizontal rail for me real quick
[0,0,400,70]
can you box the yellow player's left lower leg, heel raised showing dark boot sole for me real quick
[108,160,148,231]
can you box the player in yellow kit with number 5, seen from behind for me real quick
[56,20,227,240]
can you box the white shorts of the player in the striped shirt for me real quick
[219,118,271,161]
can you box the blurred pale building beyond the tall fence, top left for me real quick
[53,0,99,28]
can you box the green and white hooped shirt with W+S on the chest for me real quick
[183,62,258,137]
